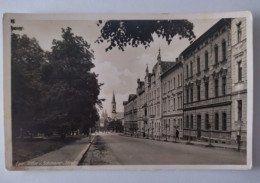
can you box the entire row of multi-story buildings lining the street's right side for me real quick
[123,18,247,145]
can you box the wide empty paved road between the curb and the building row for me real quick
[83,134,246,165]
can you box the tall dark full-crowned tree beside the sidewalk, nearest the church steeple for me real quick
[43,27,102,136]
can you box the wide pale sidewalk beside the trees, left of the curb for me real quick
[18,135,95,166]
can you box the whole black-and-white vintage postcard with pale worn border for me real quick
[3,11,253,170]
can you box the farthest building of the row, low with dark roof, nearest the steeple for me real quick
[123,94,138,135]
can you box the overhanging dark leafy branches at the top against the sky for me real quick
[96,20,195,51]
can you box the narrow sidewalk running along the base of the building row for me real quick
[120,134,246,151]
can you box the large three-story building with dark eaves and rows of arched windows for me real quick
[181,19,232,143]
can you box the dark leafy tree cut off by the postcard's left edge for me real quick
[11,33,45,136]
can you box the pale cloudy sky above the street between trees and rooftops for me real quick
[13,19,219,115]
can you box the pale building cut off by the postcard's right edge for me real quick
[231,18,247,146]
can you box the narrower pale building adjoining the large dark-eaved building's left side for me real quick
[161,59,183,138]
